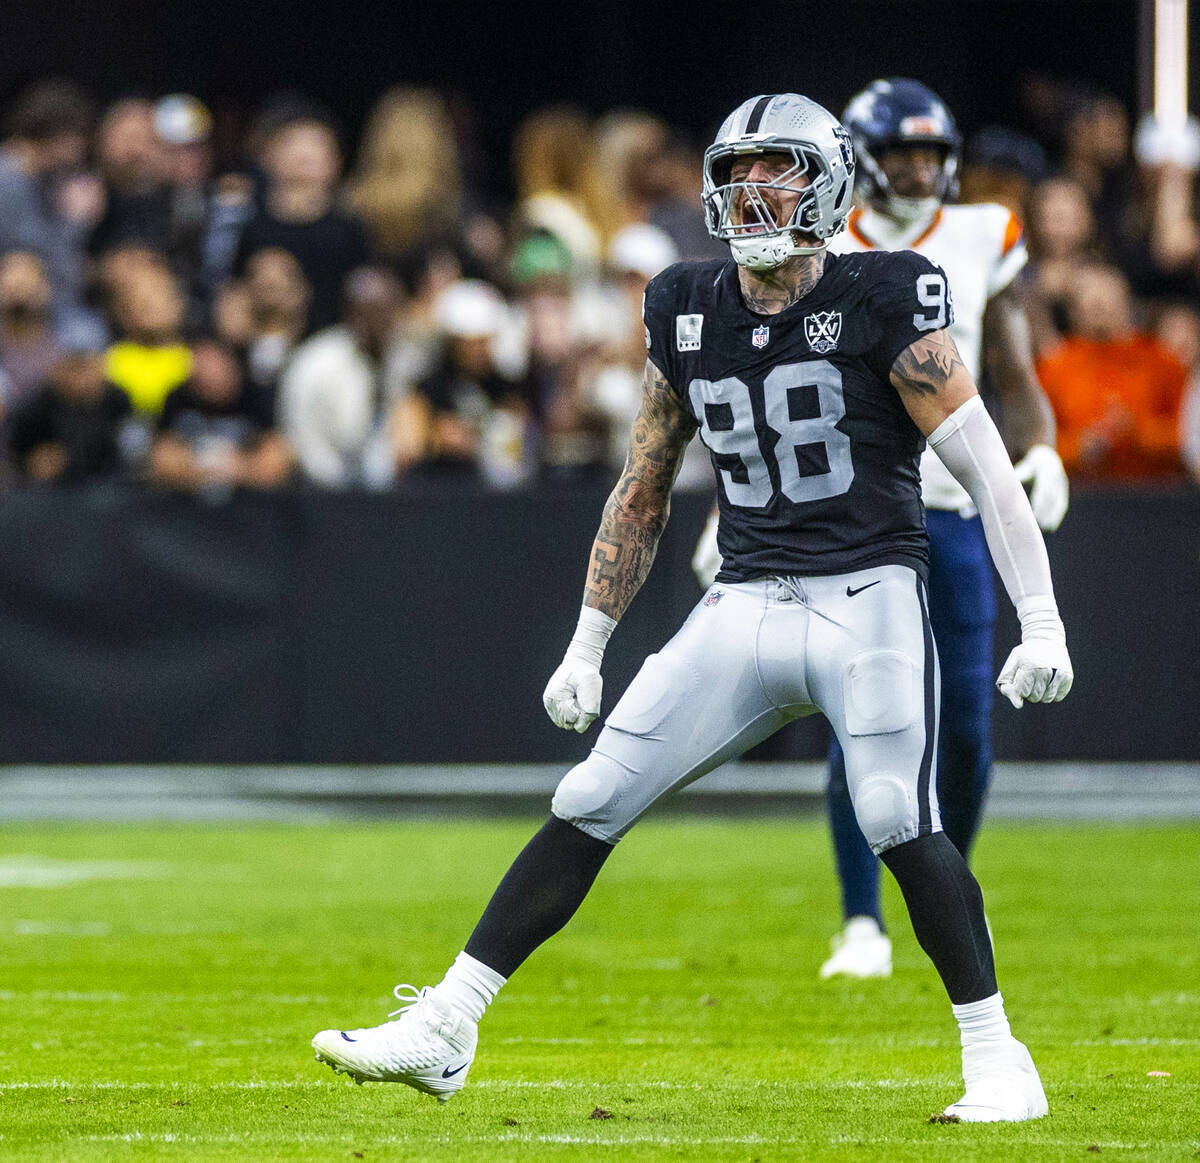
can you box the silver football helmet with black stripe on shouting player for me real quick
[701,92,854,270]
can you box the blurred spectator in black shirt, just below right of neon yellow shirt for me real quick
[149,340,293,499]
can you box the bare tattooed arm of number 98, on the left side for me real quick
[583,361,696,618]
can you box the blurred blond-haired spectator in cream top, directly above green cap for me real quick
[512,106,604,278]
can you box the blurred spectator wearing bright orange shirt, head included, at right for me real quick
[1038,264,1186,480]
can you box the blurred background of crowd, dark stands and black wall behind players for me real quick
[0,0,1200,795]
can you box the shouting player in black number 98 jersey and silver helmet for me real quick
[313,94,1072,1121]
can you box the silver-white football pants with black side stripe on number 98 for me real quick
[552,565,941,853]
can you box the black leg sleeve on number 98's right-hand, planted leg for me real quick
[881,832,996,1006]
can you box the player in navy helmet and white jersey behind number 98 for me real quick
[821,78,1067,977]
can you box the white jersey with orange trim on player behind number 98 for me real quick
[829,203,1028,516]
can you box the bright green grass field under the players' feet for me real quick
[0,820,1200,1161]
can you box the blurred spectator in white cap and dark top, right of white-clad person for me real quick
[412,278,535,488]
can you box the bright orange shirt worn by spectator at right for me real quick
[1038,335,1187,480]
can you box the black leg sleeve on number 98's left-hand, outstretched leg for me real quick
[466,816,612,977]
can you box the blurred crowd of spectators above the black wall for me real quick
[0,78,1200,497]
